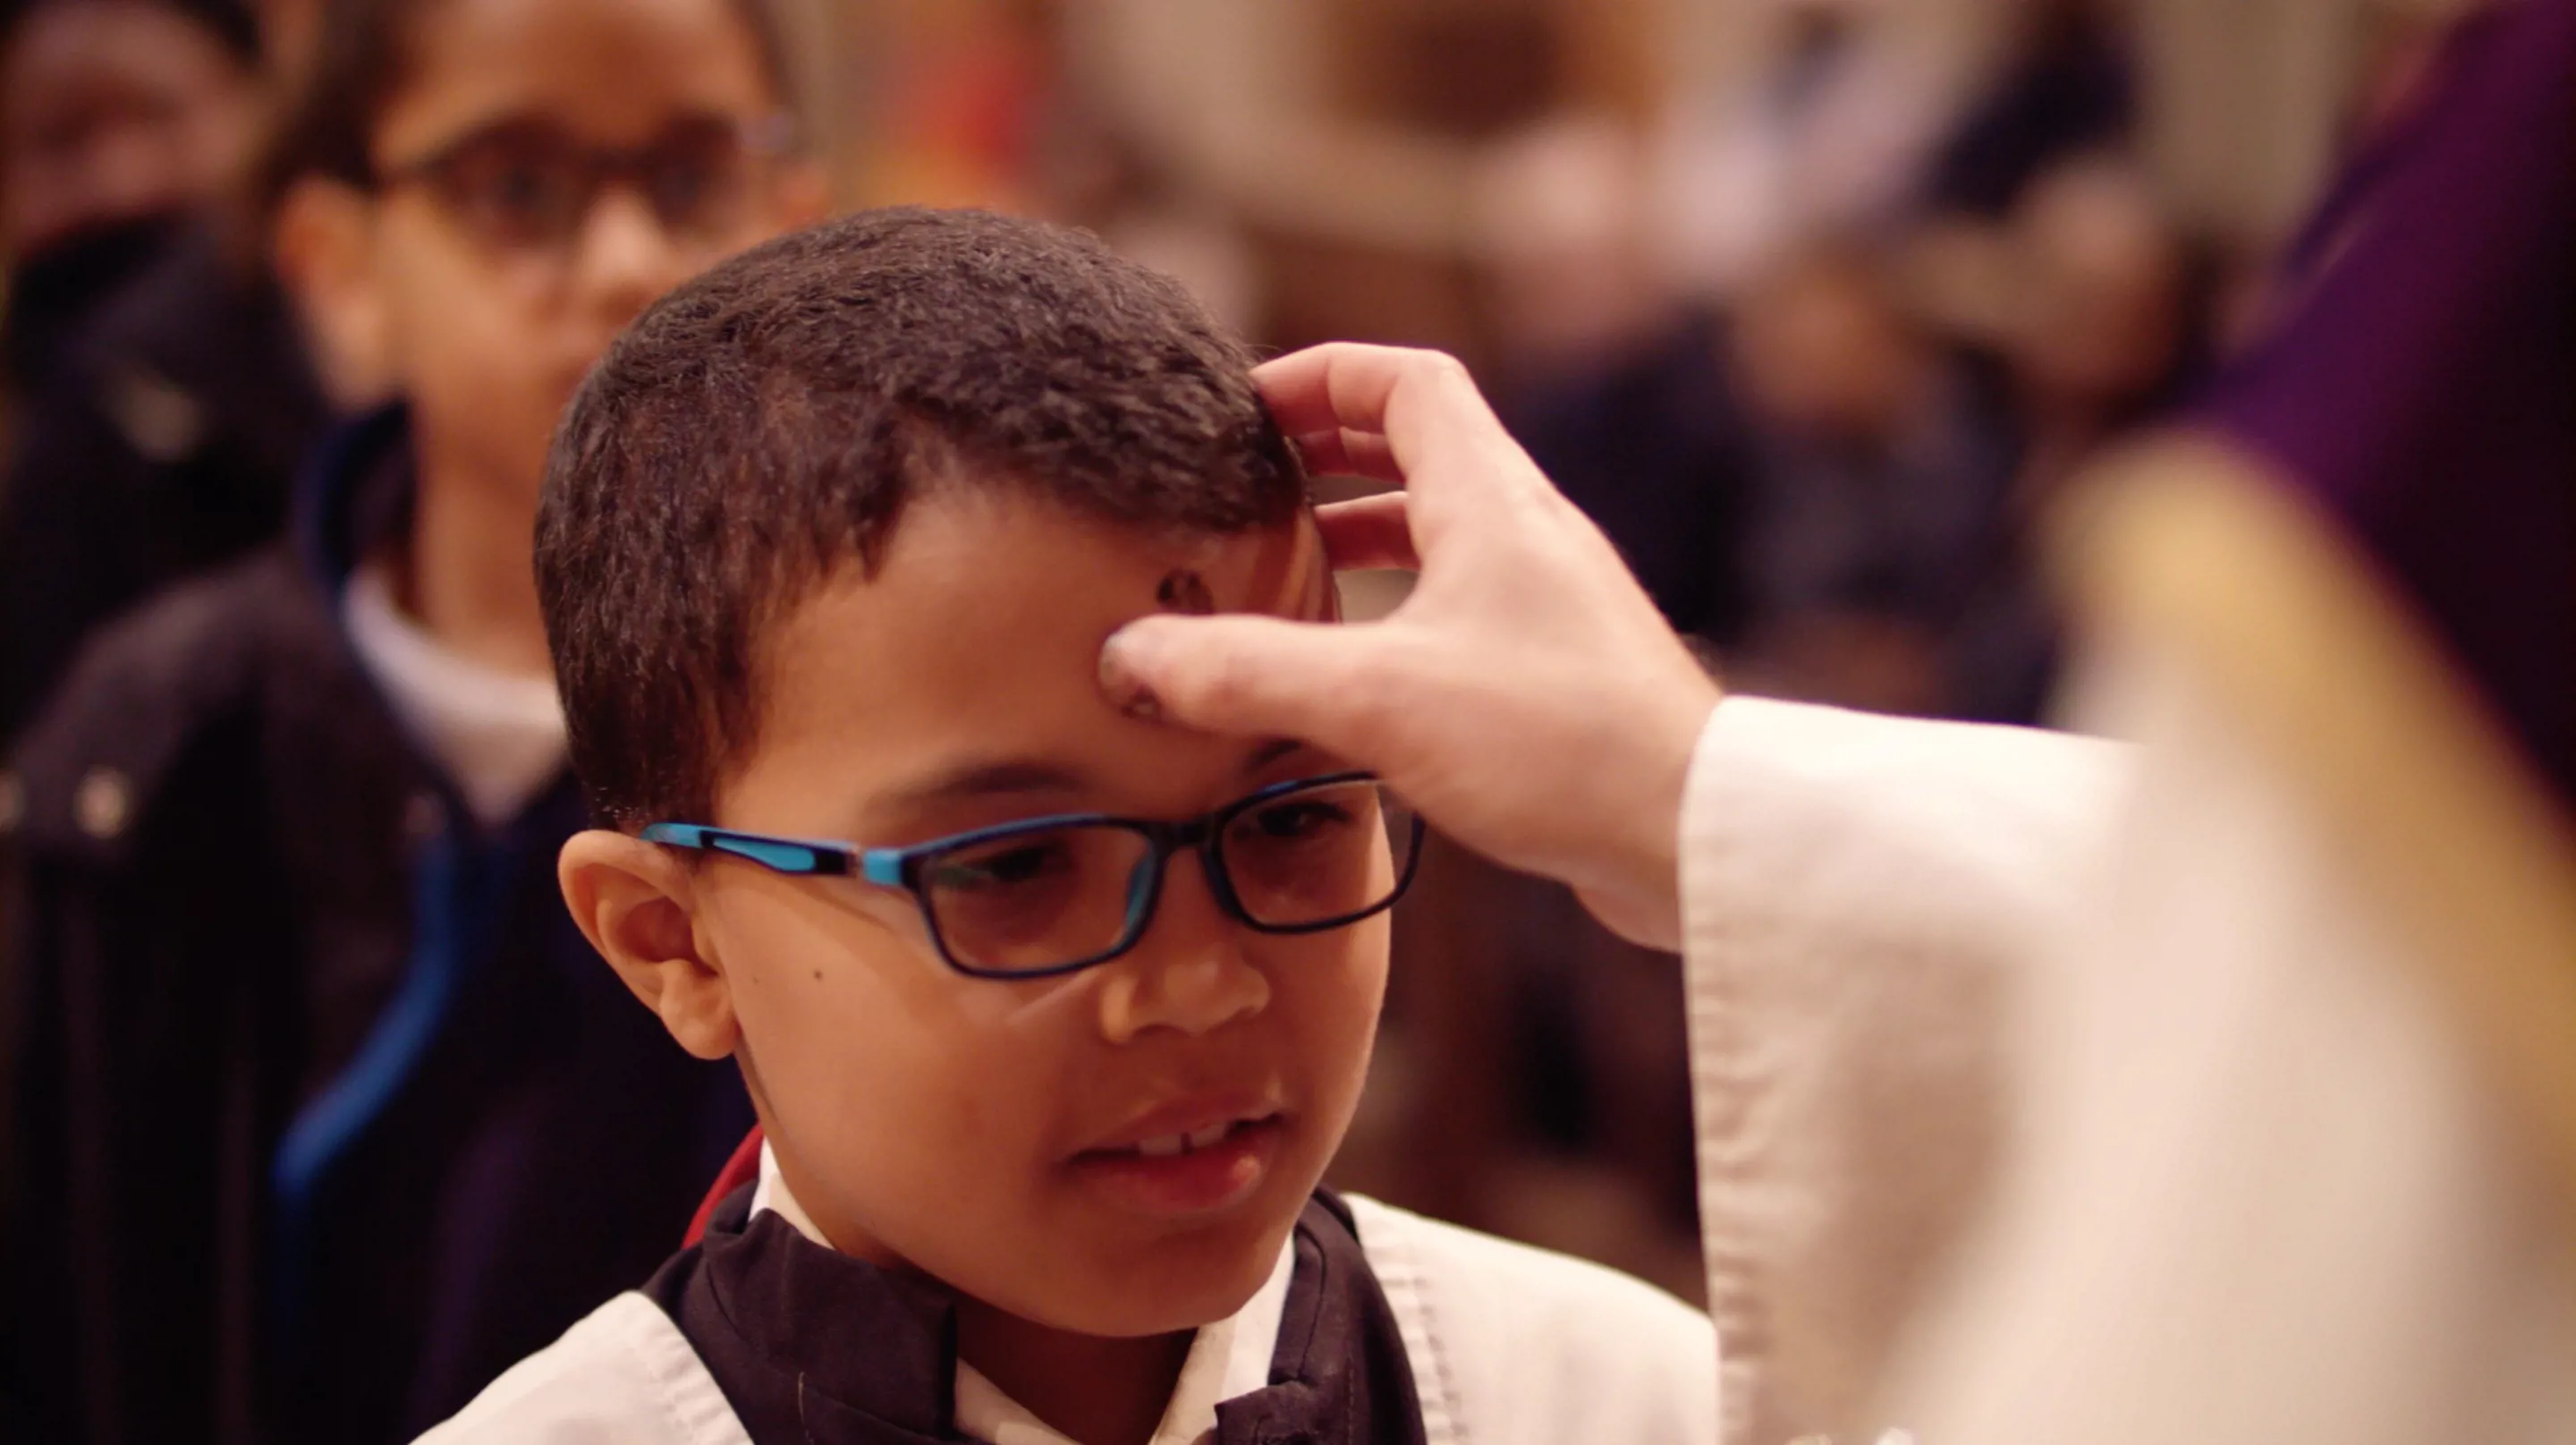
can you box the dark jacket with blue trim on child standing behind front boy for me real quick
[0,402,750,1445]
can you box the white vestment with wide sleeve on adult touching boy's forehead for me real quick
[1682,654,2576,1445]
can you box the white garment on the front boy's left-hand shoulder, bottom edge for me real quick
[418,1293,752,1445]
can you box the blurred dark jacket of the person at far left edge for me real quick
[0,229,330,739]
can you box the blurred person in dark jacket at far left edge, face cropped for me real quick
[0,0,330,739]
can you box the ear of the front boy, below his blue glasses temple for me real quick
[554,829,741,1058]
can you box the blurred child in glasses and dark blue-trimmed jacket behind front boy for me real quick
[0,0,822,1442]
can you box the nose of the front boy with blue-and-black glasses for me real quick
[1100,853,1270,1043]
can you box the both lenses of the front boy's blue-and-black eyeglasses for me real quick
[917,780,1414,973]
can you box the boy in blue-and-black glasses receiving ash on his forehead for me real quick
[433,211,1716,1445]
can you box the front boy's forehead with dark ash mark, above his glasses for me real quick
[726,492,1332,827]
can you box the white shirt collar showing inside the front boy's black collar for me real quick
[752,1143,1296,1445]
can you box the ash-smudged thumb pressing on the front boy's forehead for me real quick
[1100,616,1384,746]
